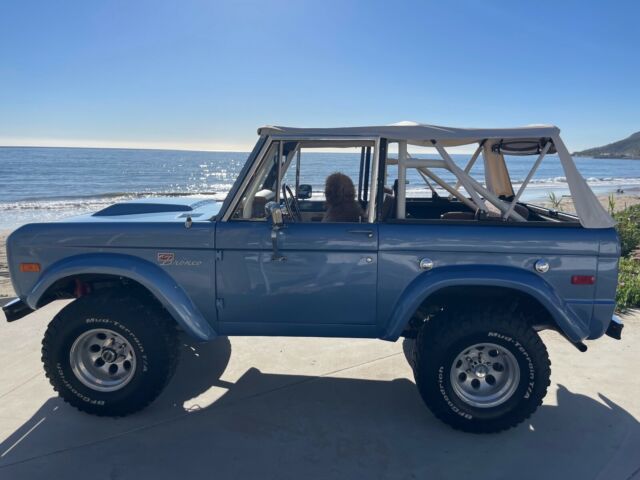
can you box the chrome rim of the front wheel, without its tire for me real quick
[69,328,136,392]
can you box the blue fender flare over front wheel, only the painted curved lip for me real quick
[25,253,216,340]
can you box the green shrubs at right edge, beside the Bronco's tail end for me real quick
[614,205,640,310]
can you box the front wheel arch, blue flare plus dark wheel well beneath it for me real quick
[25,253,216,340]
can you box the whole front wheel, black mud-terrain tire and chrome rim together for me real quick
[42,292,178,416]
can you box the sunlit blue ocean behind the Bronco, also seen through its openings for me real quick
[0,147,640,230]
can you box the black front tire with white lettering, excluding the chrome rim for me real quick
[42,291,179,417]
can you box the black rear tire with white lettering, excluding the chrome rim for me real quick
[414,307,551,433]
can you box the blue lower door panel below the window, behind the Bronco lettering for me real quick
[216,221,378,336]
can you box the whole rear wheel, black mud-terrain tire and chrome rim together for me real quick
[414,308,551,433]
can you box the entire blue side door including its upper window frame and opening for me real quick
[216,138,378,337]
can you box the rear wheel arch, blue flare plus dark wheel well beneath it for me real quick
[382,265,589,343]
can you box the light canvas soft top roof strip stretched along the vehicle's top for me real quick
[258,122,560,147]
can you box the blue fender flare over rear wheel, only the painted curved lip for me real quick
[382,265,589,343]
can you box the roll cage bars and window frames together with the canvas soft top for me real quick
[222,123,614,228]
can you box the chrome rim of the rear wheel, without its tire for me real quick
[450,343,520,408]
